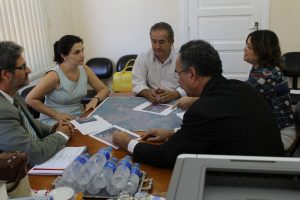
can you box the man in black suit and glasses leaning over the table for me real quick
[113,40,284,167]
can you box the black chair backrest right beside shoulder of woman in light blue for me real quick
[86,57,113,79]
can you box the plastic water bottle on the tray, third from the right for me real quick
[87,158,118,194]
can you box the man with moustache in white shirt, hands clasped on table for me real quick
[132,22,185,103]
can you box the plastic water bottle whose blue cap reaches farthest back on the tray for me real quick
[76,147,112,185]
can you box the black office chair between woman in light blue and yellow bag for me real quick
[81,57,113,104]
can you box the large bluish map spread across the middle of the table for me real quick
[89,96,182,131]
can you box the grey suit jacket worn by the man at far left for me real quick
[0,93,67,165]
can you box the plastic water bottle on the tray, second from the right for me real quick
[111,156,132,189]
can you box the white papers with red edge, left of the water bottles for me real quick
[28,146,87,175]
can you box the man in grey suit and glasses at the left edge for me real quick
[0,42,72,165]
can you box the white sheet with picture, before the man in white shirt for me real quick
[132,101,176,116]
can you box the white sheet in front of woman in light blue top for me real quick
[71,115,112,135]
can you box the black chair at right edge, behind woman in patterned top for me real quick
[282,52,300,105]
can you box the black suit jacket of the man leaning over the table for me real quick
[133,76,283,167]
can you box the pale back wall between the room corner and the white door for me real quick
[73,0,179,63]
